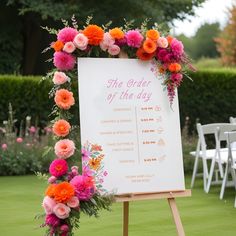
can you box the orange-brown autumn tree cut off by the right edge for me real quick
[216,5,236,66]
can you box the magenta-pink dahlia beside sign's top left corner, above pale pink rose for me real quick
[53,52,75,71]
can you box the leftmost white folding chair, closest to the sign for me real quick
[190,123,228,192]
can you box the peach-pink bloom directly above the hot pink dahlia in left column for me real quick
[54,139,75,159]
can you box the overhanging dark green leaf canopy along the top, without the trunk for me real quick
[7,0,204,25]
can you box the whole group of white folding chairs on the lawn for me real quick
[190,117,236,207]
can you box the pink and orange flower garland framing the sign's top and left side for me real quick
[39,17,194,236]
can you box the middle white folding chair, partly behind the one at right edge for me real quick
[206,123,236,193]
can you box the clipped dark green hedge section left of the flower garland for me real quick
[0,75,52,126]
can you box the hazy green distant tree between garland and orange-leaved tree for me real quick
[178,23,220,59]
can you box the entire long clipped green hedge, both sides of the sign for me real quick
[0,69,236,132]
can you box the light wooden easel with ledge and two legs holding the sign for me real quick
[116,190,191,236]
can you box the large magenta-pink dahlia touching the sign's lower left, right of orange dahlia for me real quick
[70,175,95,201]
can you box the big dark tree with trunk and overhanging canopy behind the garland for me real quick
[6,0,205,74]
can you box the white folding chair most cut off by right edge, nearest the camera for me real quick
[220,131,236,207]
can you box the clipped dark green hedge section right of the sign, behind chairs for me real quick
[179,69,236,133]
